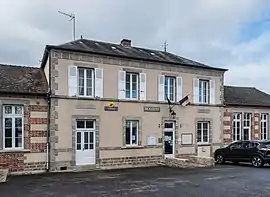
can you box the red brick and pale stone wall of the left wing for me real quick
[0,97,48,174]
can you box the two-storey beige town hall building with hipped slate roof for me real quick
[41,39,226,171]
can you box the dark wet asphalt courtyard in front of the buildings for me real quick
[0,165,270,197]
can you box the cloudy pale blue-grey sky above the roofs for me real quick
[0,0,270,93]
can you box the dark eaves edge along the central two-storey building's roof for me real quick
[46,45,229,72]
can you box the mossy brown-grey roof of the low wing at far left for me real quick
[0,64,48,94]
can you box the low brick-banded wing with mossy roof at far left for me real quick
[0,64,48,173]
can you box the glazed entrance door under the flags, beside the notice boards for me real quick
[164,121,175,158]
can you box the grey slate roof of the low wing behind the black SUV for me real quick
[224,86,270,107]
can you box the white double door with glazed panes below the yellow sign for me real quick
[76,120,96,165]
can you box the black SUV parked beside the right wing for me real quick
[214,140,270,167]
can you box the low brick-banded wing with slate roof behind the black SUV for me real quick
[223,86,270,144]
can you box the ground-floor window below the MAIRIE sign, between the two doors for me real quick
[125,120,139,146]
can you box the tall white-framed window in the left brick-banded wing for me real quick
[3,105,24,149]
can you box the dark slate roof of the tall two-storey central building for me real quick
[41,39,227,71]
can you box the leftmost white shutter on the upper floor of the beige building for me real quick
[68,65,78,96]
